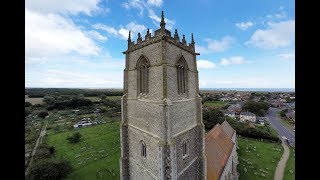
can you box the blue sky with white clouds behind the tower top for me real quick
[25,0,295,88]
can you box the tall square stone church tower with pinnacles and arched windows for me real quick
[120,11,206,180]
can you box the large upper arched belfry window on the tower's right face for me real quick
[176,56,188,94]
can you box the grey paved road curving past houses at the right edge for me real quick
[267,107,295,144]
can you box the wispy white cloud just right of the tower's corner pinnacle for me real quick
[195,36,235,54]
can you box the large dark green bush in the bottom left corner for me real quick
[28,159,72,180]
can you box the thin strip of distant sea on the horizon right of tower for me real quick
[200,88,295,92]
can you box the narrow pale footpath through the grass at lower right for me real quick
[274,139,290,180]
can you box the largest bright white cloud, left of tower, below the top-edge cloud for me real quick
[25,9,100,57]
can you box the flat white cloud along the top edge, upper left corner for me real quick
[26,0,100,15]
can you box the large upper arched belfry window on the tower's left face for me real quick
[137,56,150,94]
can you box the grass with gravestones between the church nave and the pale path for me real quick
[237,137,283,180]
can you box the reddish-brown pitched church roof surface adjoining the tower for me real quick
[205,121,234,180]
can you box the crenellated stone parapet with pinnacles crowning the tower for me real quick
[123,11,196,54]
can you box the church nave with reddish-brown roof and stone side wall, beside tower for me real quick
[205,121,239,180]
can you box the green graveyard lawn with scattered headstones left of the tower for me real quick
[46,121,120,180]
